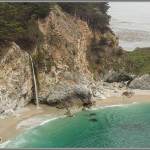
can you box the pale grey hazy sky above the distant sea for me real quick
[108,2,150,28]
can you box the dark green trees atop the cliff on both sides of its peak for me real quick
[0,2,110,49]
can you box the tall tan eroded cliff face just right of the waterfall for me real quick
[35,6,96,103]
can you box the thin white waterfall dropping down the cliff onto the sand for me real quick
[29,54,39,108]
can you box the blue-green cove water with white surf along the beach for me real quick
[2,104,150,148]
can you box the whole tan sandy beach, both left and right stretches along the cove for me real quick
[0,89,150,144]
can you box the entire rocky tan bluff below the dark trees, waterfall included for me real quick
[0,4,149,118]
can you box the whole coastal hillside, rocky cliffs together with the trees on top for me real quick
[0,3,148,116]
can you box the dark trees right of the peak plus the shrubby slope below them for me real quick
[59,2,123,79]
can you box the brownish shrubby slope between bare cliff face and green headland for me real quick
[87,32,124,78]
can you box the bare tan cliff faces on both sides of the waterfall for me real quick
[0,6,109,115]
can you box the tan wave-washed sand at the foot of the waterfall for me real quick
[0,104,65,143]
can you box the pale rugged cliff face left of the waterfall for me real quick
[0,43,32,115]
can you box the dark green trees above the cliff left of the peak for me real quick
[0,3,50,48]
